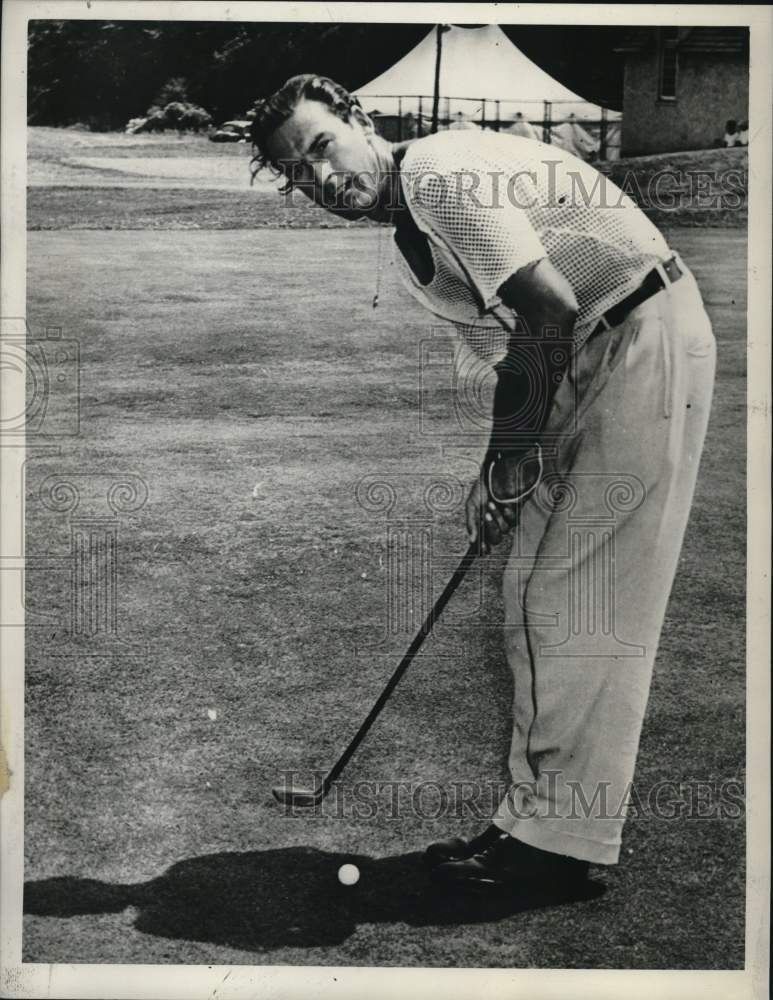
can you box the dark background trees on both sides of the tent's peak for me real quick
[28,20,625,129]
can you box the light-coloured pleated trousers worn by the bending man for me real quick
[494,262,715,864]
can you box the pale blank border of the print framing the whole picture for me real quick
[0,0,773,1000]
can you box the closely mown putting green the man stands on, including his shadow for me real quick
[24,229,746,969]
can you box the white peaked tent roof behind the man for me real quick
[355,24,620,121]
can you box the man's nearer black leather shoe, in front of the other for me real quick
[432,831,589,896]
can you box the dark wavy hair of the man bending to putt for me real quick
[250,73,362,193]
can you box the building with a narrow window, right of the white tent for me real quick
[615,27,749,156]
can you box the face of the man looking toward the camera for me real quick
[267,100,379,218]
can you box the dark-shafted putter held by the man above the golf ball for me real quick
[272,541,480,807]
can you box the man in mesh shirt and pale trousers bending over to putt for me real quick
[253,75,715,895]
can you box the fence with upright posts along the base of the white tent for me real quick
[367,94,622,160]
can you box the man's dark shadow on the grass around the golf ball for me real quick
[24,847,604,951]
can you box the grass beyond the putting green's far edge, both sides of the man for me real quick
[27,127,748,230]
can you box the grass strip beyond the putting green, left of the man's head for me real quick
[27,127,362,230]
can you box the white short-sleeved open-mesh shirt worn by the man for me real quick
[394,131,669,363]
